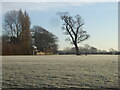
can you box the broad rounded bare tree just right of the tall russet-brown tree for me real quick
[31,26,58,53]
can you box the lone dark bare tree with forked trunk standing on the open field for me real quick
[58,12,90,55]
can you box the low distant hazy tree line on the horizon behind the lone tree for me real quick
[58,44,120,55]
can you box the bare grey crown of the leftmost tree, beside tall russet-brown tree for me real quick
[3,10,22,39]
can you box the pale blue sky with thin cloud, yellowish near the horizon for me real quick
[0,2,118,50]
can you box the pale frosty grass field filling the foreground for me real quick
[2,55,118,88]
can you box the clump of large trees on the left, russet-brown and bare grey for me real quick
[1,10,58,55]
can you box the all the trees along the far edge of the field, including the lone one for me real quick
[0,10,119,55]
